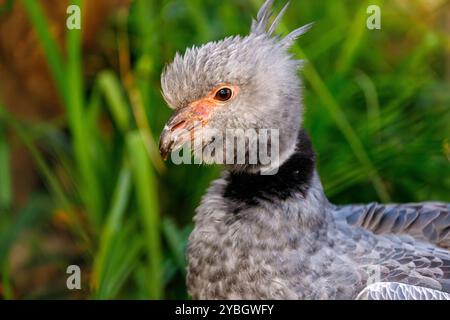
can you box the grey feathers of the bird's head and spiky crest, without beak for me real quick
[161,0,311,170]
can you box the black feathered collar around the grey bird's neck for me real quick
[223,130,328,226]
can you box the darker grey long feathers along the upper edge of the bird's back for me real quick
[332,202,450,248]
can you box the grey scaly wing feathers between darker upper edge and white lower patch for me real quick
[333,209,450,293]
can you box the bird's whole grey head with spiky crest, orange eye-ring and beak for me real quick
[160,0,310,174]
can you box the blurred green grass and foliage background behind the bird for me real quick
[0,0,450,299]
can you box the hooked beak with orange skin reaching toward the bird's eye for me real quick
[159,98,217,160]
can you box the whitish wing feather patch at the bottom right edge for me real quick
[356,282,450,300]
